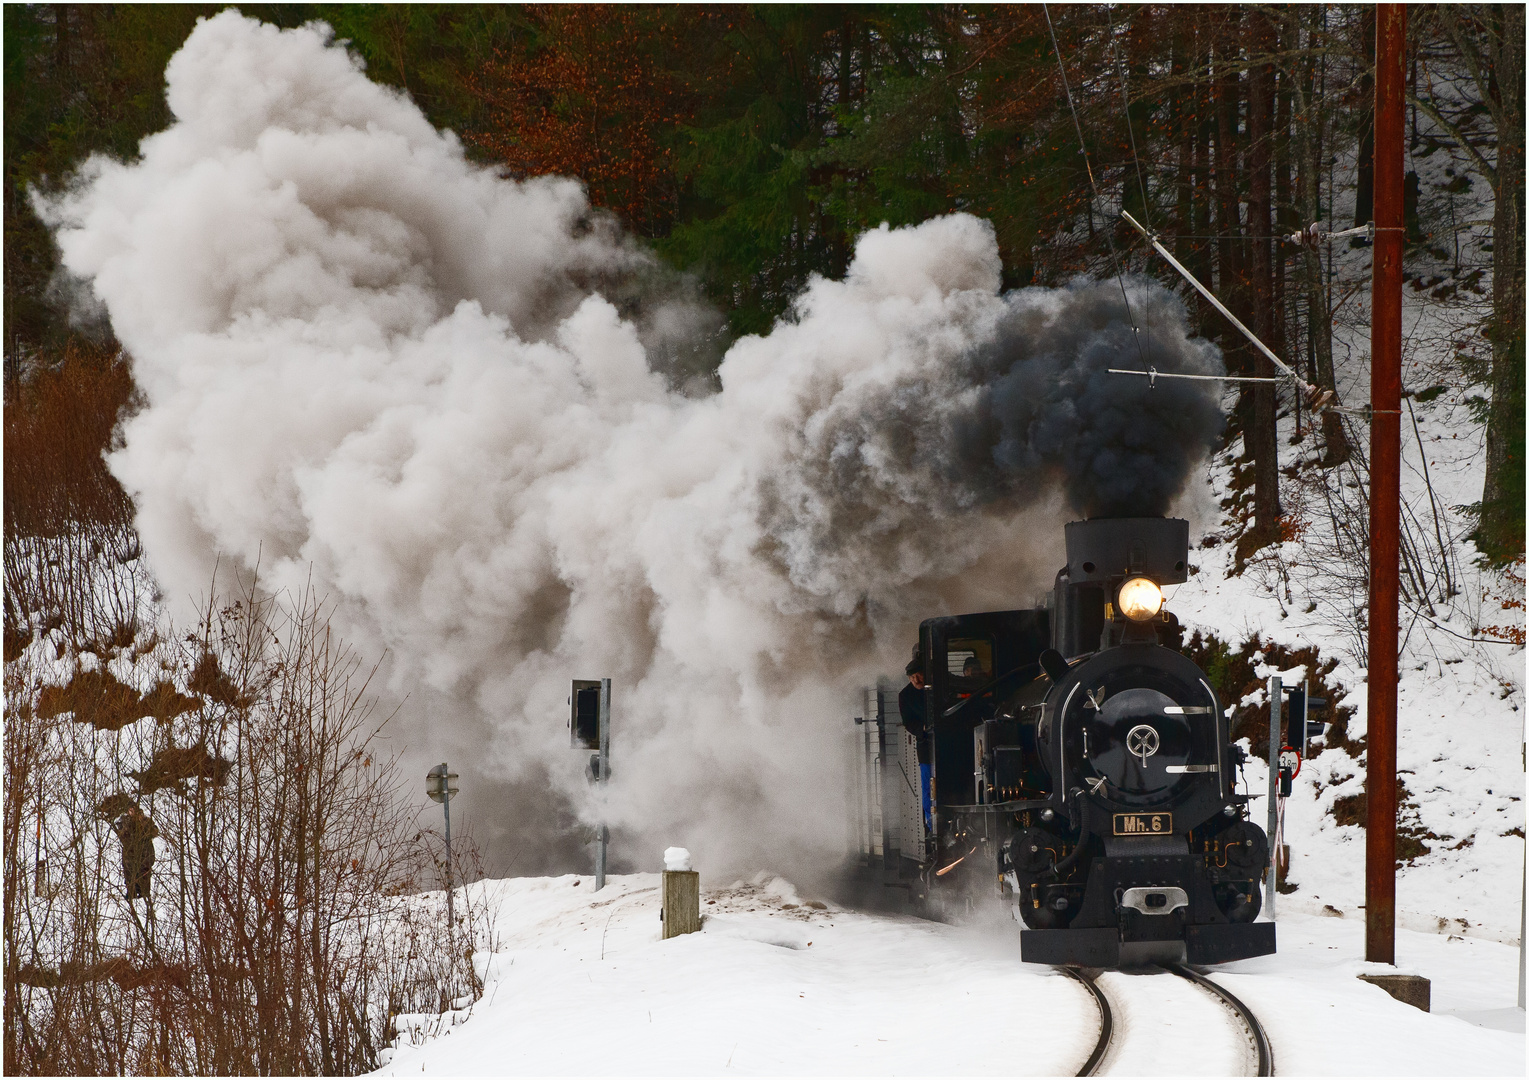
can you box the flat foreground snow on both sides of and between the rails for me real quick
[381,858,1524,1075]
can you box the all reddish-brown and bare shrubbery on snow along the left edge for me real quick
[3,343,486,1075]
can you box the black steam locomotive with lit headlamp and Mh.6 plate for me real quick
[902,517,1275,967]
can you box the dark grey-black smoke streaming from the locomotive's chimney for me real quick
[760,278,1225,610]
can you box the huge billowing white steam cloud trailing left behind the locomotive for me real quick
[43,11,1219,870]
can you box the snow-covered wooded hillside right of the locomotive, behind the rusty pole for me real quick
[1170,140,1524,942]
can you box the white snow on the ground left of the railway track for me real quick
[384,873,1093,1075]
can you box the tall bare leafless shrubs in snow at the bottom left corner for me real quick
[5,572,488,1075]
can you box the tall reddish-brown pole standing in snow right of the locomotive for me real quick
[1369,3,1407,964]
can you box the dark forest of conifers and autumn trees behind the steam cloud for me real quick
[5,5,1524,561]
